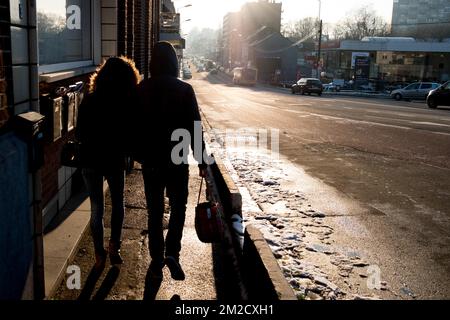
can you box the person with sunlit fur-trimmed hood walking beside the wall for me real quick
[76,57,139,270]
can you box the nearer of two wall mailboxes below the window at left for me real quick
[40,94,64,142]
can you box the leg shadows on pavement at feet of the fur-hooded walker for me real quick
[78,266,120,300]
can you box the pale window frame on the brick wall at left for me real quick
[36,0,100,76]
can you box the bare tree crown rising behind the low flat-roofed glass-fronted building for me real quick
[333,7,390,40]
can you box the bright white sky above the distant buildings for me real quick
[174,0,393,32]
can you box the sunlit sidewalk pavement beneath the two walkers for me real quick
[49,165,221,300]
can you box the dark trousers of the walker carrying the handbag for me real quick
[143,164,189,263]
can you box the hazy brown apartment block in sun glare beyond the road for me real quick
[221,0,298,83]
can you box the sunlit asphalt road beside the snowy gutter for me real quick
[190,73,450,299]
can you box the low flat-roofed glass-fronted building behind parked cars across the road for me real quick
[321,37,450,82]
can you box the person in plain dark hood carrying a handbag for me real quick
[138,42,206,280]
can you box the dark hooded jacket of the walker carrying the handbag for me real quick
[138,42,205,168]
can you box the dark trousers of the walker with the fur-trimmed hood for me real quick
[83,169,125,252]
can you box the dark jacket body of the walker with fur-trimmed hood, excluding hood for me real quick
[76,93,130,174]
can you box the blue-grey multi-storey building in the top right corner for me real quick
[392,0,450,39]
